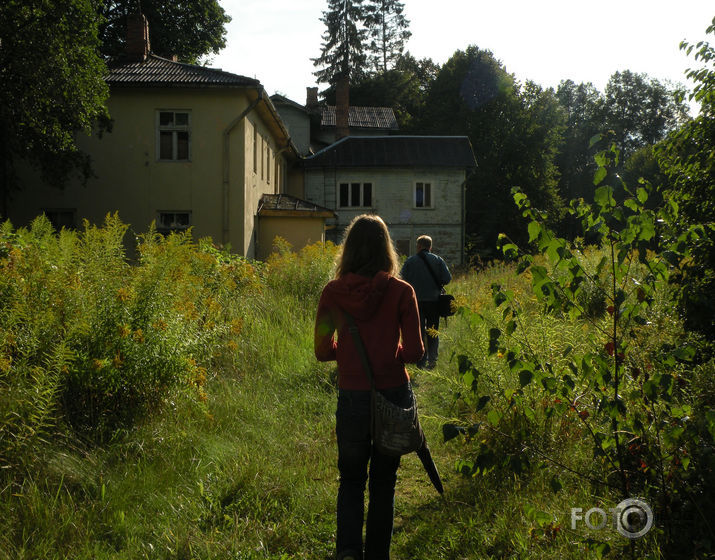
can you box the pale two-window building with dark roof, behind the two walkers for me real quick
[301,136,476,264]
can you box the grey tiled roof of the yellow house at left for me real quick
[106,54,261,87]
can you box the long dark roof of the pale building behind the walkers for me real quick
[303,136,477,168]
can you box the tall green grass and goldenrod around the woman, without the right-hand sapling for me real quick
[0,221,712,560]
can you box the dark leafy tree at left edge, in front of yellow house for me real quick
[0,0,108,214]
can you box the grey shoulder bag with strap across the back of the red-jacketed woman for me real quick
[343,311,424,457]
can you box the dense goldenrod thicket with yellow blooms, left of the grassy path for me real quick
[0,215,259,463]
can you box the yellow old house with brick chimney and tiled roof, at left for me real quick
[8,16,332,257]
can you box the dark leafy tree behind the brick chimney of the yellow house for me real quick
[99,0,231,63]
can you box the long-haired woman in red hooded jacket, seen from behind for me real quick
[315,215,424,560]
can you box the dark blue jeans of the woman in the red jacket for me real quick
[335,383,411,560]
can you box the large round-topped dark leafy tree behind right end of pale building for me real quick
[416,46,564,257]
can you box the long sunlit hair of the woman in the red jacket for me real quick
[335,214,400,278]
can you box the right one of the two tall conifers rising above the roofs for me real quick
[364,0,412,73]
